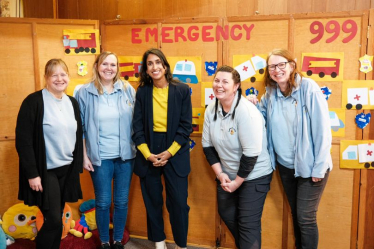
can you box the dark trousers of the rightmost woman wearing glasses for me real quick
[277,163,330,249]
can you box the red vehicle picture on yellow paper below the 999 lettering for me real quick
[301,52,344,81]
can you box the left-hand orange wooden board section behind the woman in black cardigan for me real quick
[0,18,99,222]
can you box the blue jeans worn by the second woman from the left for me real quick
[90,158,134,243]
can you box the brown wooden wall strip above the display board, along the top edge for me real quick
[23,0,374,21]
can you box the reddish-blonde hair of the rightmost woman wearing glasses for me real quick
[264,49,302,96]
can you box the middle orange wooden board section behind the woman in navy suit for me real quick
[101,18,222,245]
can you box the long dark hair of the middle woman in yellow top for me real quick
[139,48,179,87]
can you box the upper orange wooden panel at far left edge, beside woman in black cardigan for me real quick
[0,21,35,138]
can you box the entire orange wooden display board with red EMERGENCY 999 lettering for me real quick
[0,8,374,249]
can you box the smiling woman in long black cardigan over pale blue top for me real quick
[16,59,83,249]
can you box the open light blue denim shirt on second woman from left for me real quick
[76,81,136,166]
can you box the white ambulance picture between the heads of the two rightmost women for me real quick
[233,54,267,83]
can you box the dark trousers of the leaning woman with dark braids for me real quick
[217,173,273,249]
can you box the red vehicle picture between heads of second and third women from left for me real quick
[118,56,142,81]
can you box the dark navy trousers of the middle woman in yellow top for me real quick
[140,133,190,247]
